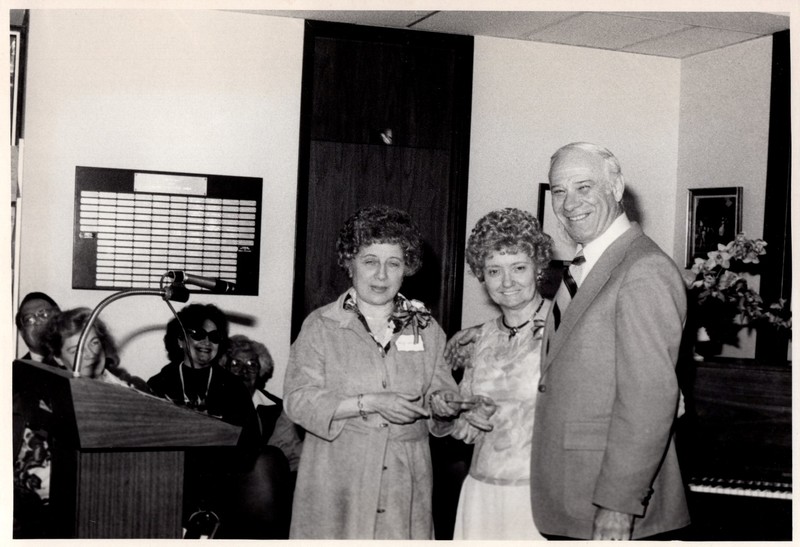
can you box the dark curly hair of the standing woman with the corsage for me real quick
[336,205,423,276]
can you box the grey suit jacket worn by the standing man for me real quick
[531,223,689,538]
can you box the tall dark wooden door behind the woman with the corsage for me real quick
[292,21,473,339]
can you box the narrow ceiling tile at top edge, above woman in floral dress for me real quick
[412,11,578,39]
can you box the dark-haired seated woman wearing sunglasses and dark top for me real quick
[147,304,258,431]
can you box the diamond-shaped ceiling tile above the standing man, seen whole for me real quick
[530,13,686,49]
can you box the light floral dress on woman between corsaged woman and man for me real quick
[454,300,550,540]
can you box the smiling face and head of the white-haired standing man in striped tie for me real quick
[550,149,624,245]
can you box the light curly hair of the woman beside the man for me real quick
[467,207,553,282]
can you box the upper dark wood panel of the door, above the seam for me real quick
[311,36,455,149]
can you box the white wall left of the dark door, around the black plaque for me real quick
[20,10,303,394]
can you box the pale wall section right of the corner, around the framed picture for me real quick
[674,36,772,358]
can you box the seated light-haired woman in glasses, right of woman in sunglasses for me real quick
[224,335,304,473]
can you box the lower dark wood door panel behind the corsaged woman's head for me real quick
[303,142,450,322]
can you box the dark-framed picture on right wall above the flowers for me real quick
[686,186,742,268]
